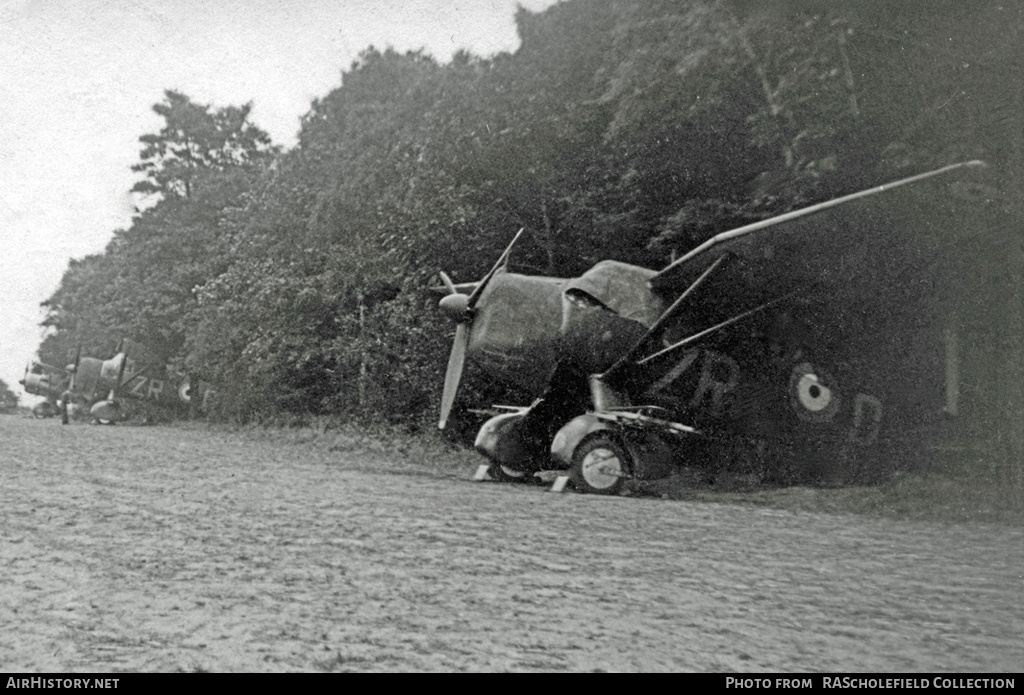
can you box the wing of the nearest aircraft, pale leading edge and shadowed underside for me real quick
[650,161,995,291]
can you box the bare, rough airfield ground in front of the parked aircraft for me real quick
[0,417,1024,672]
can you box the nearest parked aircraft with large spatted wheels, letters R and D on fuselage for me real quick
[439,162,999,493]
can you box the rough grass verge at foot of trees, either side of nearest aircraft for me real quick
[165,418,1024,525]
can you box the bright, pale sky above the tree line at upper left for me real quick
[0,0,556,404]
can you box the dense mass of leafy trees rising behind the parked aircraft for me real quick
[40,0,1024,433]
